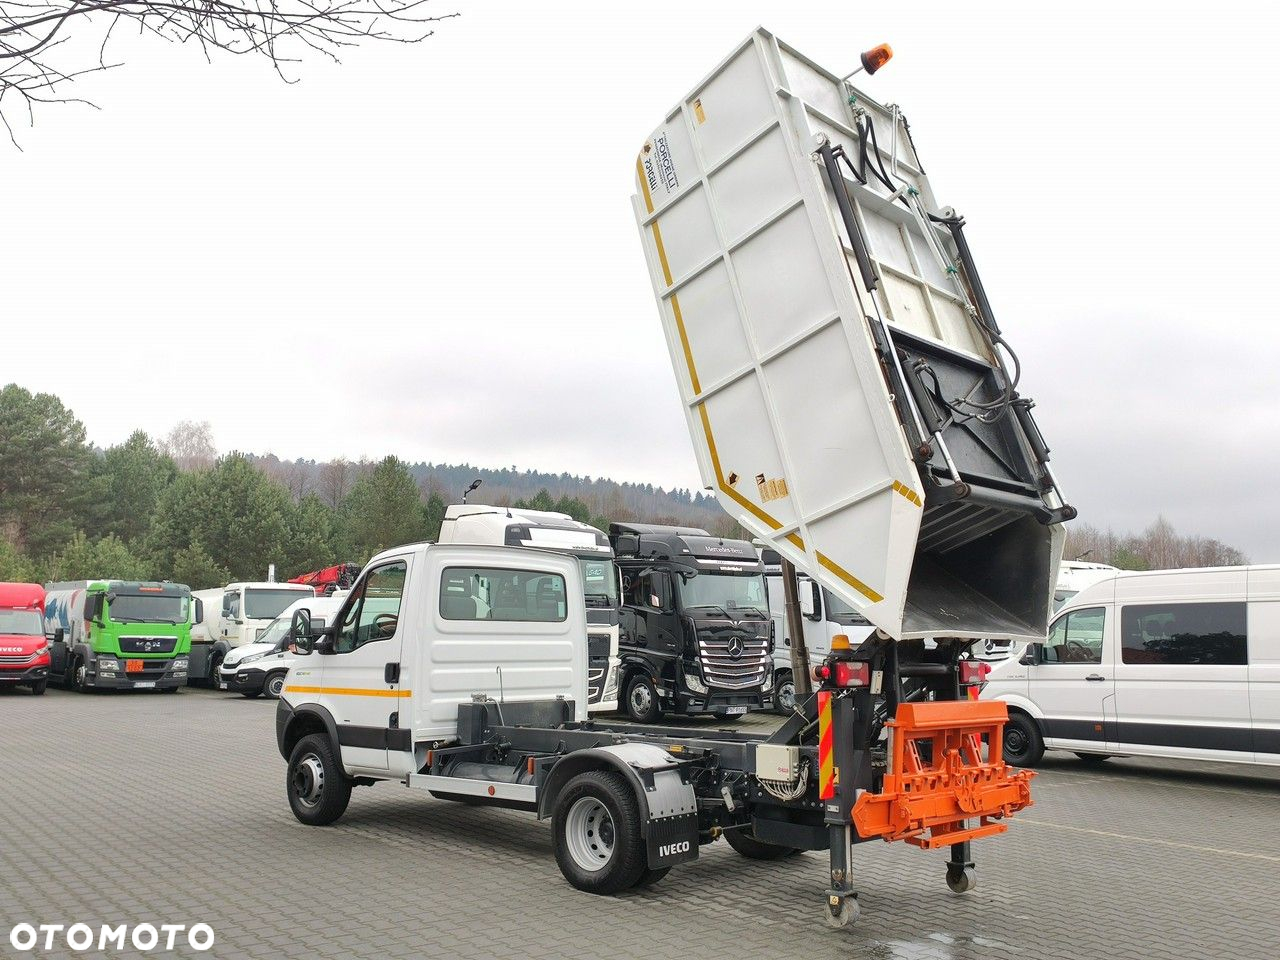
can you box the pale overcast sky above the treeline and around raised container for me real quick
[0,0,1280,561]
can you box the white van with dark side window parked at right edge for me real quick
[982,566,1280,767]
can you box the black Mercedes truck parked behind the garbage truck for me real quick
[609,524,773,723]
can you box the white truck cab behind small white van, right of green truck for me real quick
[191,581,316,686]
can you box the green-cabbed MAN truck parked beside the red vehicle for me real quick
[45,580,192,694]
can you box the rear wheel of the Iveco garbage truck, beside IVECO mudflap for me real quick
[552,771,648,896]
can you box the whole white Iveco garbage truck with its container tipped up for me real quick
[276,29,1074,927]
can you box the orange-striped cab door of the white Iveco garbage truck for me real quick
[319,556,411,769]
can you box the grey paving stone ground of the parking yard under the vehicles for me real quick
[0,690,1280,960]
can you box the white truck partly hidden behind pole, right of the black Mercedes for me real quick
[756,544,876,714]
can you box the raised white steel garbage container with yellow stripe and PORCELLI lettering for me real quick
[632,29,1075,640]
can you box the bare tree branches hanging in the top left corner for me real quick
[0,0,458,148]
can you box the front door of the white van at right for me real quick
[1027,605,1116,750]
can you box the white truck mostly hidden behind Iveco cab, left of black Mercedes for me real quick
[439,503,620,713]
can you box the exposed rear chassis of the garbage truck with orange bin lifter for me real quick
[406,637,1033,927]
